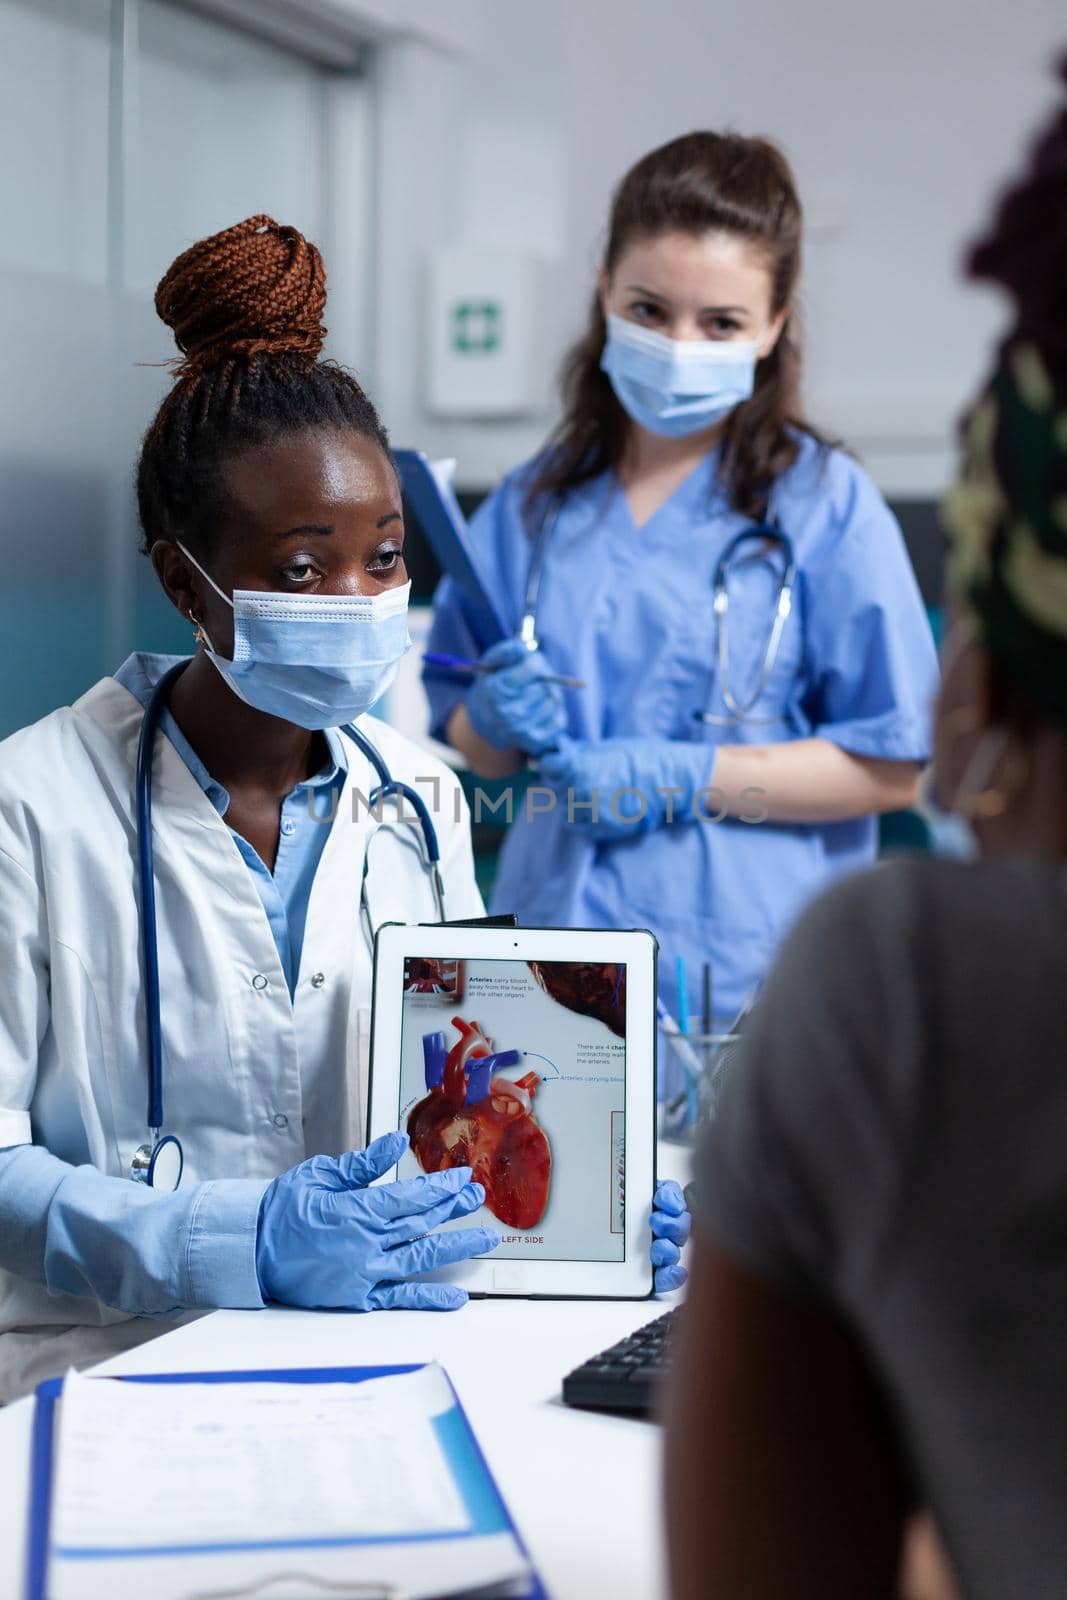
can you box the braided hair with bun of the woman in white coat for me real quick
[138,216,392,555]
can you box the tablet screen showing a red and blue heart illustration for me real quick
[397,957,625,1261]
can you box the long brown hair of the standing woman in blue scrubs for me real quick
[530,133,817,518]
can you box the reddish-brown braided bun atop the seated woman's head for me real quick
[155,216,326,376]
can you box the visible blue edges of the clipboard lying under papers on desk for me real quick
[24,1362,549,1600]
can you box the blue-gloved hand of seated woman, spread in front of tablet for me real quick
[256,1133,501,1310]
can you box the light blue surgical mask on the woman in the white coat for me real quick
[178,544,411,728]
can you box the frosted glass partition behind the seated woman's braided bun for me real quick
[0,0,373,738]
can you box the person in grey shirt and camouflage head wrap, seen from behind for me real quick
[667,59,1067,1600]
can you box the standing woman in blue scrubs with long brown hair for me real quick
[427,133,936,1049]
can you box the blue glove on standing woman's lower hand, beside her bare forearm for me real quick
[537,739,720,838]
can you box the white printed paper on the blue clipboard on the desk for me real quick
[53,1373,470,1549]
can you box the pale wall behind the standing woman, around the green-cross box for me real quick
[369,0,1067,493]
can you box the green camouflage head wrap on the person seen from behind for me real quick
[942,347,1067,730]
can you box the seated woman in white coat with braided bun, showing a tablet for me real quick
[0,218,688,1398]
